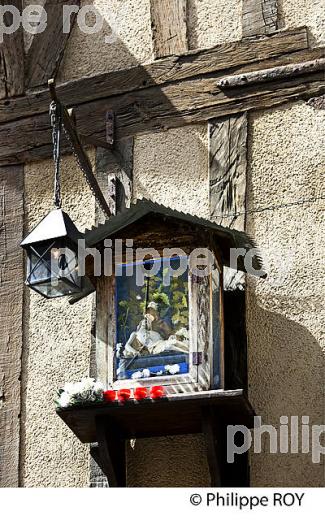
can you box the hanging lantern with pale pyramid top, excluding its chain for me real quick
[21,209,83,298]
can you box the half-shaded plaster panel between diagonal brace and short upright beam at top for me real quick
[58,0,153,81]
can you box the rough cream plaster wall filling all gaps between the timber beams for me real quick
[21,0,325,487]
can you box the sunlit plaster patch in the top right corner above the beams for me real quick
[278,0,325,46]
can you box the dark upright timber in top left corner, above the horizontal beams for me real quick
[0,0,24,98]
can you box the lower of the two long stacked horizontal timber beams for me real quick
[0,57,325,164]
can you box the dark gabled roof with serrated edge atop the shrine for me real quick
[85,199,263,274]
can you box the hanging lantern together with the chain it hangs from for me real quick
[21,101,94,303]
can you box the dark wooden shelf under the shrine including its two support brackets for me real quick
[57,390,255,487]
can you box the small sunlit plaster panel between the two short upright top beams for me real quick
[187,0,242,49]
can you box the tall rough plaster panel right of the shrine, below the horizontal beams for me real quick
[247,102,325,486]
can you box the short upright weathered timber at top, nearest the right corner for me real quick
[242,0,279,38]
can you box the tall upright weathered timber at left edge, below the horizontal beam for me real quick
[0,166,24,487]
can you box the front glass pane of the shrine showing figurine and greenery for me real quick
[115,257,189,379]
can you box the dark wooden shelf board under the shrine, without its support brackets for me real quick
[57,390,254,443]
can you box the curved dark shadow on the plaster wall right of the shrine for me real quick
[247,296,325,487]
